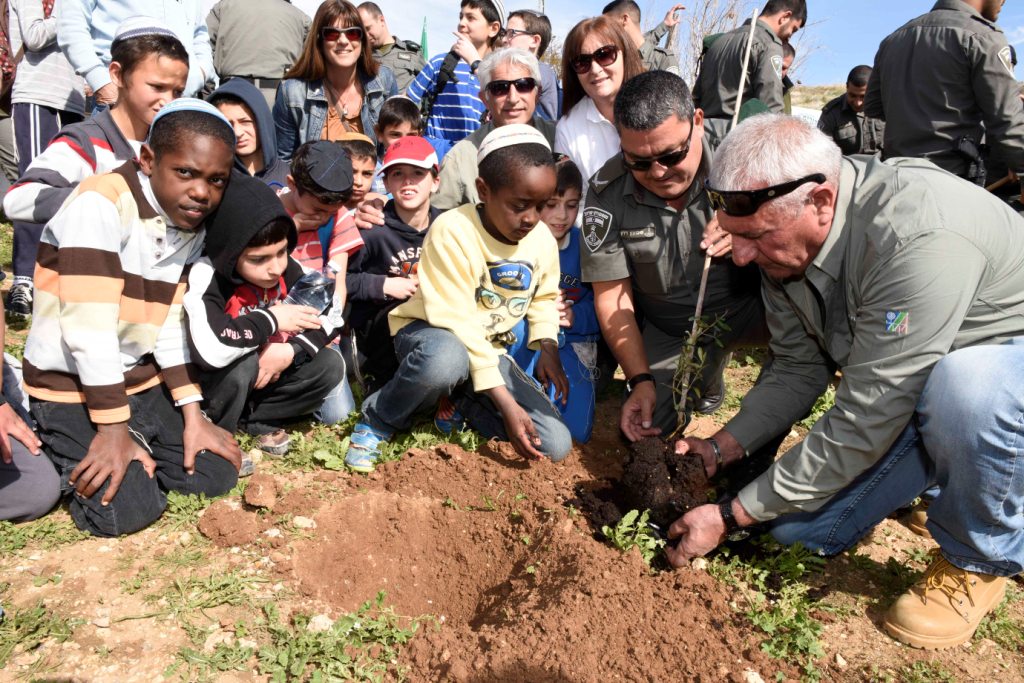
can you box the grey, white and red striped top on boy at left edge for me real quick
[3,110,140,223]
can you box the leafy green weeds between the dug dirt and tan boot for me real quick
[709,536,833,681]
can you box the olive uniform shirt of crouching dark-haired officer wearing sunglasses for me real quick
[580,141,760,337]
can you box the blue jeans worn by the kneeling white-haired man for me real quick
[769,337,1024,577]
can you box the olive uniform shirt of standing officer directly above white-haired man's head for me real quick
[693,19,784,119]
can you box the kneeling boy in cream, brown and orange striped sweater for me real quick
[24,99,242,537]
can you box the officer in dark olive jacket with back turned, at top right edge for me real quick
[864,0,1024,197]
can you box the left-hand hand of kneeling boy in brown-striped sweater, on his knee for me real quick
[70,423,154,505]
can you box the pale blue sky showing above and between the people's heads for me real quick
[282,0,1024,85]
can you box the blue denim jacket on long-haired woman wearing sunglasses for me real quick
[273,67,398,161]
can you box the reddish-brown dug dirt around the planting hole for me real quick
[197,430,790,683]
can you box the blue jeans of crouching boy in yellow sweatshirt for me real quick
[362,321,572,462]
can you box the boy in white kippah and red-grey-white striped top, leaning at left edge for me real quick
[3,16,188,315]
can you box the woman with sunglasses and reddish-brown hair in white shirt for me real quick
[555,16,644,199]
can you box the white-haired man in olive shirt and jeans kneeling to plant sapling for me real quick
[670,115,1024,648]
